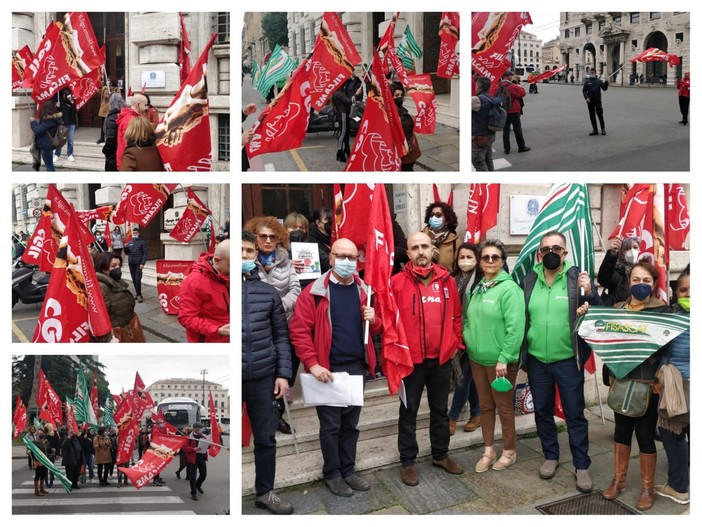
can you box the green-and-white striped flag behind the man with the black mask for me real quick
[512,183,595,283]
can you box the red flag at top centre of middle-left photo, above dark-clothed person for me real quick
[113,183,178,227]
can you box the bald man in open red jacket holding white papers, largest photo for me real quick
[290,238,382,497]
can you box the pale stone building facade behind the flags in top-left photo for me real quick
[12,12,231,170]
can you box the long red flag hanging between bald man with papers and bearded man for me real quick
[360,184,414,395]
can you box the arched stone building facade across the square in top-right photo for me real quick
[559,11,690,85]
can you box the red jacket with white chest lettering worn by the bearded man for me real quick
[390,263,465,364]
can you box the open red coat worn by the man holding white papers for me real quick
[290,271,383,372]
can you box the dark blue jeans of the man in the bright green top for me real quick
[527,355,590,470]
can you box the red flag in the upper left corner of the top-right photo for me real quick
[471,12,532,88]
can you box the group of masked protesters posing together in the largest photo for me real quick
[242,201,689,514]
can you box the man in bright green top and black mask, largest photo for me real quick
[520,231,601,492]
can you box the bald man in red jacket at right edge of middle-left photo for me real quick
[178,240,230,342]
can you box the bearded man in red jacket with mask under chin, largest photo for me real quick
[390,232,464,486]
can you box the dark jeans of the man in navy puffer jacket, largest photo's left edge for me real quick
[241,375,278,496]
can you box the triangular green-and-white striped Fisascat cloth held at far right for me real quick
[576,306,690,379]
